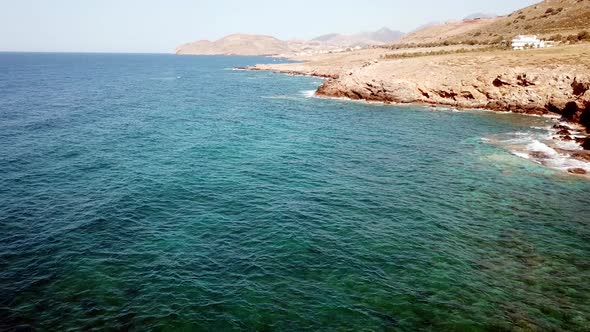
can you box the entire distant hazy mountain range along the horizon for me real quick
[175,28,404,55]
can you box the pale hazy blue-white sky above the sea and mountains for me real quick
[0,0,539,52]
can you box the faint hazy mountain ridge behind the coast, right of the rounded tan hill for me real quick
[312,28,404,47]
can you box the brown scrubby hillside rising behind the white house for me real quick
[447,0,590,43]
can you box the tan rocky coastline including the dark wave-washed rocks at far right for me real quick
[247,45,590,174]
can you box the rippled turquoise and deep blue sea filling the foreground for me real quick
[0,54,590,331]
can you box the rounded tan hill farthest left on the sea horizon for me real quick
[175,34,293,55]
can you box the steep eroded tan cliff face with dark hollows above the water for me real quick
[317,63,590,118]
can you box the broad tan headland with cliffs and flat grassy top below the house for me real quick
[249,44,590,118]
